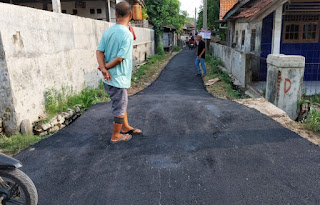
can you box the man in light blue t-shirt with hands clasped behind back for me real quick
[96,2,142,144]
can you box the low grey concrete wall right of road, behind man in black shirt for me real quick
[211,43,251,87]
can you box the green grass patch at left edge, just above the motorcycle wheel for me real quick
[0,134,46,156]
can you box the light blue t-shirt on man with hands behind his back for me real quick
[97,24,133,88]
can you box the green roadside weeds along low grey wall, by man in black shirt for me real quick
[203,54,249,100]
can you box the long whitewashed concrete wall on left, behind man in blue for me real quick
[0,3,154,135]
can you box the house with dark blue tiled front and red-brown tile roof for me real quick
[220,0,320,87]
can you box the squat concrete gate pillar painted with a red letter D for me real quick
[266,54,305,120]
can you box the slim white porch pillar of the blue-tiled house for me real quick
[271,5,282,54]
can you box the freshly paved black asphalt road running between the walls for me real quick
[16,50,320,205]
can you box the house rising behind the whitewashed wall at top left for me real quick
[0,0,149,28]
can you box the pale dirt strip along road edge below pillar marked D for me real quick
[234,98,320,146]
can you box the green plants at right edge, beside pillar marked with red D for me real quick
[298,93,320,133]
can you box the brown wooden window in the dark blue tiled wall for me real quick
[283,15,320,43]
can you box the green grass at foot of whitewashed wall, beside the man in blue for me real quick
[45,82,109,116]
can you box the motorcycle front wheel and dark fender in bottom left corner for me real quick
[0,153,38,205]
